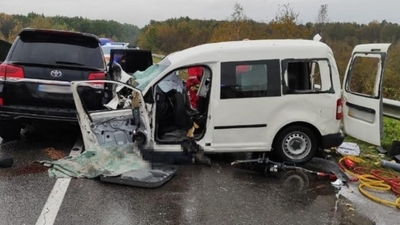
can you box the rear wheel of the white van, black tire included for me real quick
[273,125,318,164]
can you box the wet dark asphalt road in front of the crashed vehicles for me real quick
[0,124,390,225]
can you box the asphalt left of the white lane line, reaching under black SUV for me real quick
[0,125,78,224]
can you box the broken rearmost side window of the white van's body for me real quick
[285,60,332,94]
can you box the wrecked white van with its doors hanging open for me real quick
[71,40,390,163]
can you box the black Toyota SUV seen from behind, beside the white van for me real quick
[0,28,106,140]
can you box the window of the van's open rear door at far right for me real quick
[346,57,380,97]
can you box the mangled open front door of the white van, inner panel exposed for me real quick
[71,80,151,149]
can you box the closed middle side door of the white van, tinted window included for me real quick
[211,59,281,151]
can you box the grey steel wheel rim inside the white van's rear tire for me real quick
[282,131,311,159]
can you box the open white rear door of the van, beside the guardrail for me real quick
[343,43,390,146]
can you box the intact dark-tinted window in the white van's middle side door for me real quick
[221,62,268,99]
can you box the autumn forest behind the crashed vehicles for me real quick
[0,3,400,100]
